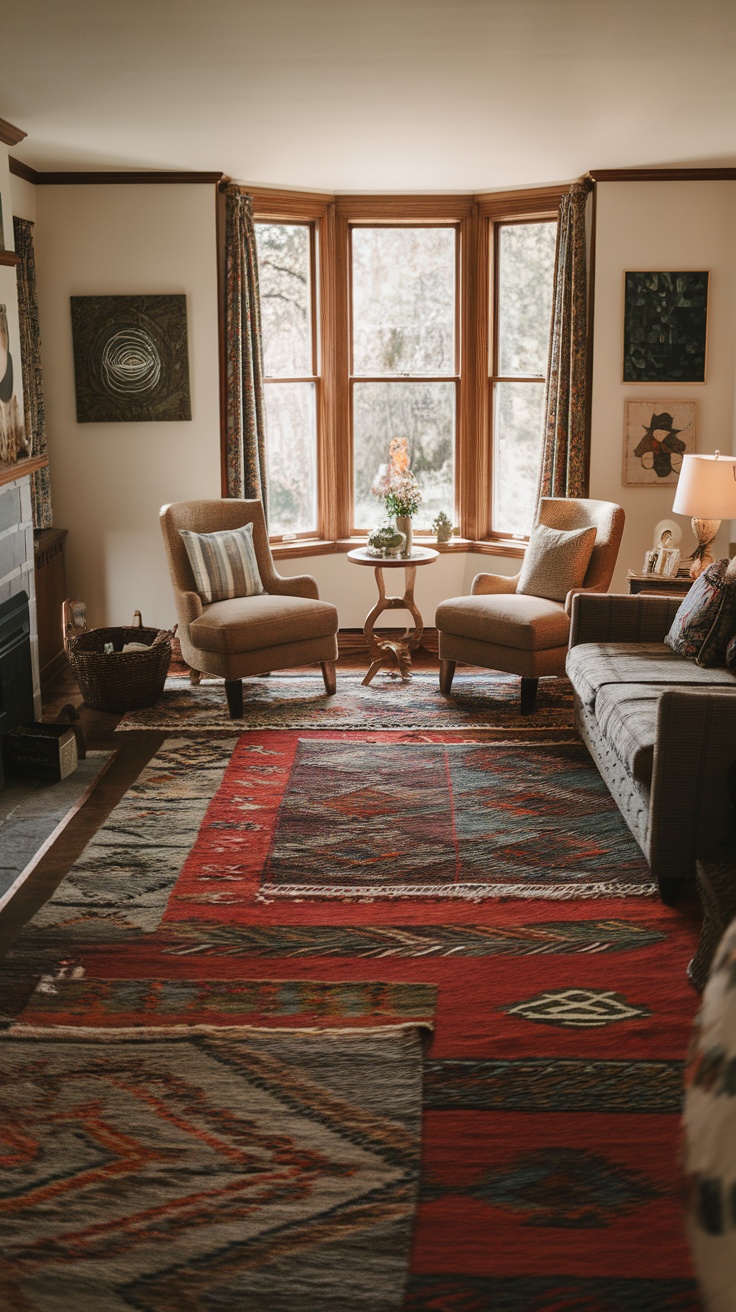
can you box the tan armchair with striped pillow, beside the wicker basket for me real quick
[160,500,338,719]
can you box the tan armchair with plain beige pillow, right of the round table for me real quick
[436,497,624,715]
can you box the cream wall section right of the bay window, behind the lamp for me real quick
[590,182,736,592]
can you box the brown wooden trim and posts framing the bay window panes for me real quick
[229,184,561,548]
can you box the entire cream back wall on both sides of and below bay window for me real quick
[25,178,736,628]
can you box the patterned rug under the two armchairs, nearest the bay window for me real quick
[118,666,575,737]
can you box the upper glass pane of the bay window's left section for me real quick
[256,223,312,378]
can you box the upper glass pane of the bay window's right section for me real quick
[499,223,558,377]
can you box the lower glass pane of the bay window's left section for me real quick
[265,383,317,535]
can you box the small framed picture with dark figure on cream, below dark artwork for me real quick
[623,399,695,487]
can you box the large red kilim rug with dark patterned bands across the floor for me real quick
[8,731,699,1312]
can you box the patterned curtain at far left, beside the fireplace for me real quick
[13,219,54,529]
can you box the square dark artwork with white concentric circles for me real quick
[71,295,192,424]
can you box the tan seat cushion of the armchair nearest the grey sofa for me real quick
[434,592,569,652]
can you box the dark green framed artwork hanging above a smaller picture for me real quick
[623,270,708,383]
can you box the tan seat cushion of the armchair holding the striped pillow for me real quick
[189,593,338,656]
